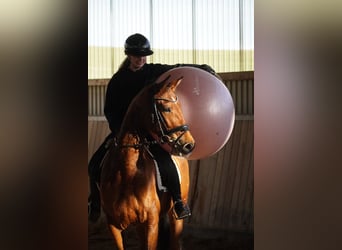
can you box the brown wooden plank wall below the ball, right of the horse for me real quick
[187,120,254,231]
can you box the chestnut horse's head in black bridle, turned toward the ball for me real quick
[152,77,195,156]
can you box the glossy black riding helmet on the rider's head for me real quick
[125,33,153,56]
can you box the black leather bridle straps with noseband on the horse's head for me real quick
[152,96,189,148]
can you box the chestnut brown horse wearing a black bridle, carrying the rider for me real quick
[100,76,195,250]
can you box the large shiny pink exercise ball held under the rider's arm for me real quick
[157,67,235,160]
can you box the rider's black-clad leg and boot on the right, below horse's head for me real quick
[150,145,191,220]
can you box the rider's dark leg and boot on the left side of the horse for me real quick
[88,134,113,222]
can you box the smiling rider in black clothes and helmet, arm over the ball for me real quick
[88,34,215,221]
